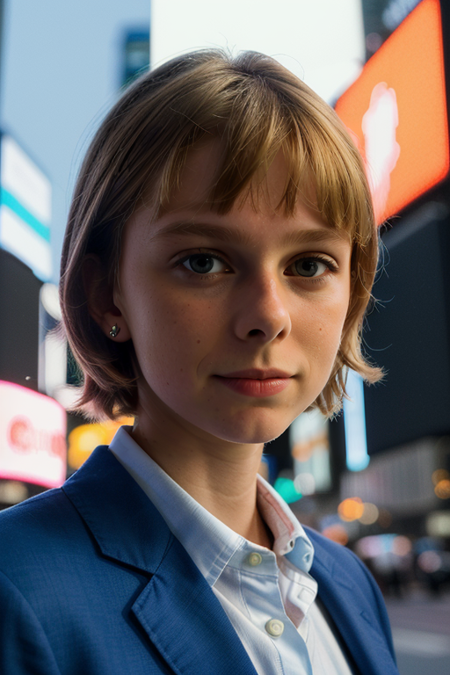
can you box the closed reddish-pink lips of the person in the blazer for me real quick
[215,368,293,398]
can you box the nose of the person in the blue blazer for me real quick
[235,274,292,343]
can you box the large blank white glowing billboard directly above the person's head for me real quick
[150,0,365,101]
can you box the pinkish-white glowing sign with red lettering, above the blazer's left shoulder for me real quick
[0,381,67,487]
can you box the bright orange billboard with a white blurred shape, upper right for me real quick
[336,0,450,223]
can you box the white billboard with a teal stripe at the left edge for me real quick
[0,134,52,281]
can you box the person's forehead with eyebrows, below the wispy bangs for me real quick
[130,139,350,248]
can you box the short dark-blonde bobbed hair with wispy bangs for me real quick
[60,50,381,418]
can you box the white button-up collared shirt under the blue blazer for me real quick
[110,427,351,675]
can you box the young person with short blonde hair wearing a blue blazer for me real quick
[0,51,398,675]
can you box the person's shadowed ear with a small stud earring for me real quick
[82,253,131,342]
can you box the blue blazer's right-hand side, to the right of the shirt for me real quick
[308,530,398,675]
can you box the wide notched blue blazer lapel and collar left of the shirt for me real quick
[62,447,256,675]
